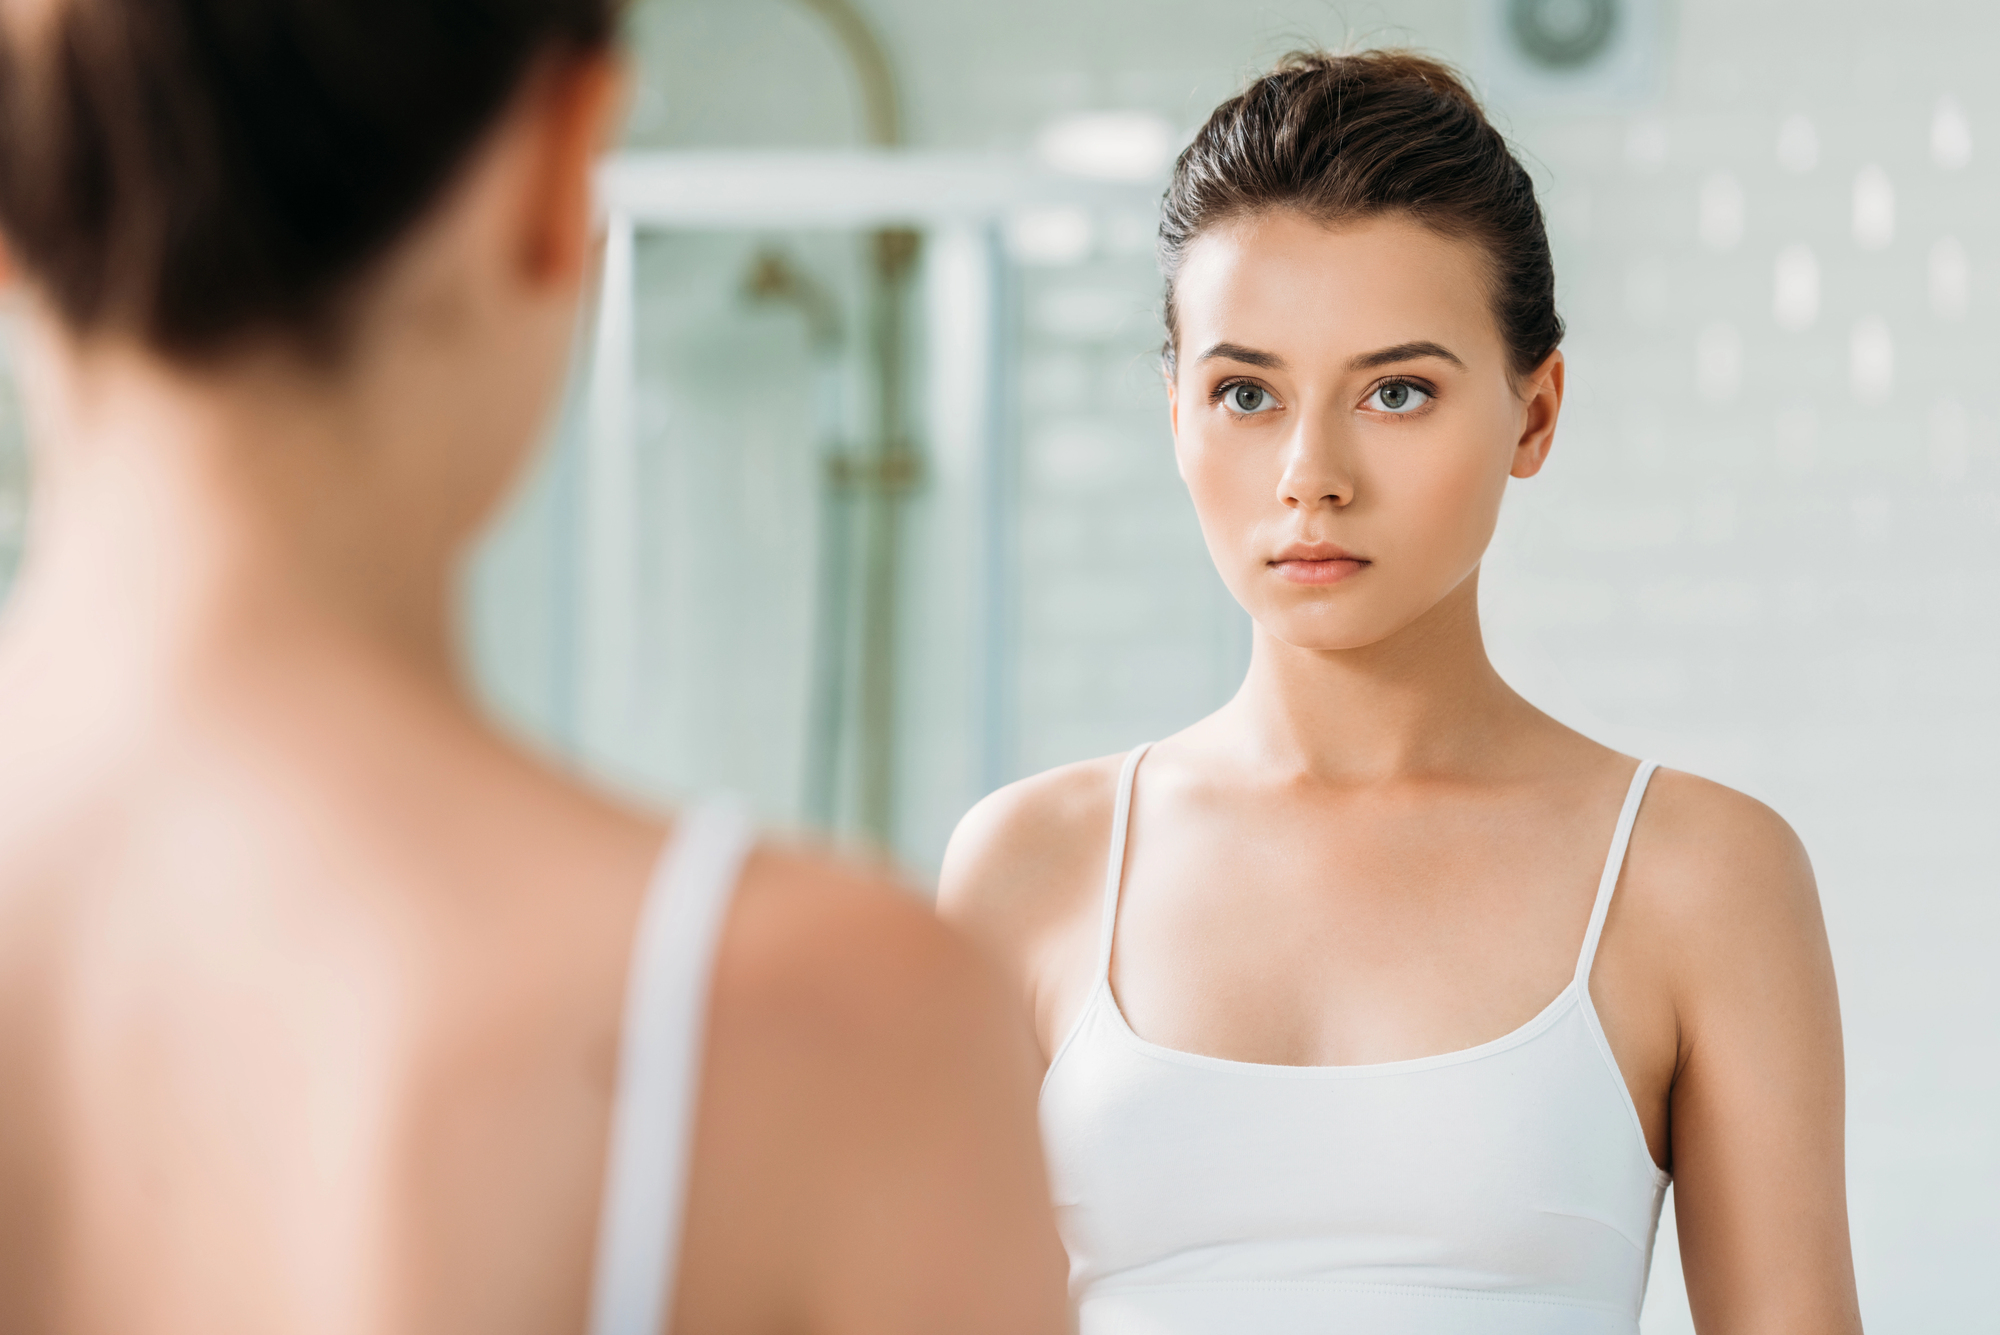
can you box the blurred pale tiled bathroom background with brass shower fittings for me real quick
[0,0,2000,1335]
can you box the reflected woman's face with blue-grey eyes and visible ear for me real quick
[1170,210,1562,650]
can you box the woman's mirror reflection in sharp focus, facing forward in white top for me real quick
[942,52,1858,1335]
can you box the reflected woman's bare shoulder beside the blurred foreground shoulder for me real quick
[938,755,1124,955]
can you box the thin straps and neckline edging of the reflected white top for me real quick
[1042,741,1660,1087]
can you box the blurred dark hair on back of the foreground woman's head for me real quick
[0,0,616,358]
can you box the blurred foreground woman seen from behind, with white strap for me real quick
[0,0,1066,1335]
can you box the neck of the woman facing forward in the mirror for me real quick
[1214,572,1544,781]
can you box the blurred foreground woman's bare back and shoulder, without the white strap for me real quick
[0,619,1060,1333]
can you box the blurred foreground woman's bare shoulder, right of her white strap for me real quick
[674,847,1062,1335]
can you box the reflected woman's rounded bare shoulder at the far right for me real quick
[1618,769,1826,995]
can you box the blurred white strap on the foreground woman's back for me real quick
[590,799,752,1335]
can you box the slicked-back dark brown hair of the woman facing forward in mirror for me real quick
[1160,50,1562,376]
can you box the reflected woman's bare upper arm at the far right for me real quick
[1670,785,1860,1335]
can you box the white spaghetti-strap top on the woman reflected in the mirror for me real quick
[1042,747,1668,1335]
